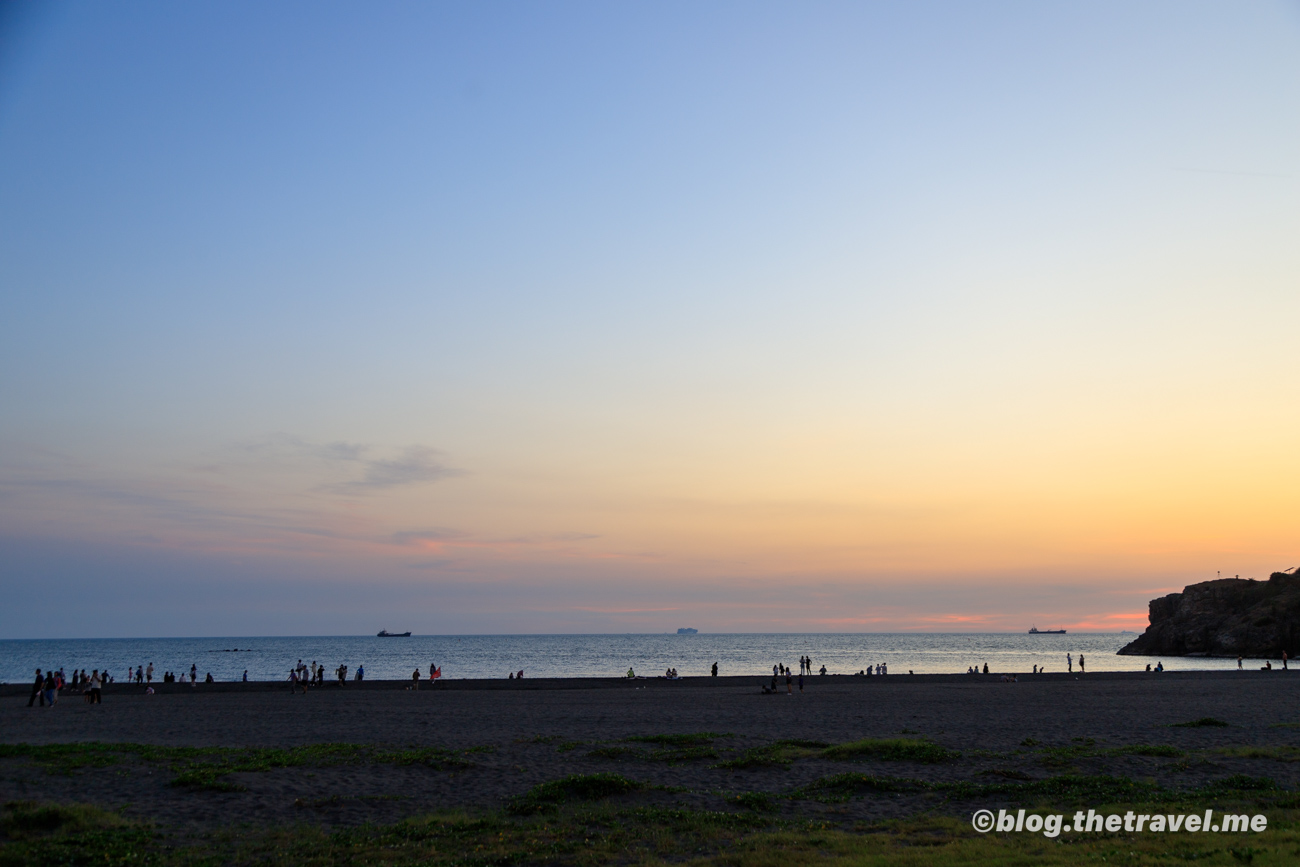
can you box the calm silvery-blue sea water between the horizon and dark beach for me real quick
[0,633,1262,684]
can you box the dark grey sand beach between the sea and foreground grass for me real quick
[0,671,1300,831]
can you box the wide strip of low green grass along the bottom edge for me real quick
[0,795,1300,867]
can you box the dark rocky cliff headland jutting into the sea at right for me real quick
[1119,569,1300,659]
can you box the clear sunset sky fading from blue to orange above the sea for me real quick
[0,1,1300,638]
